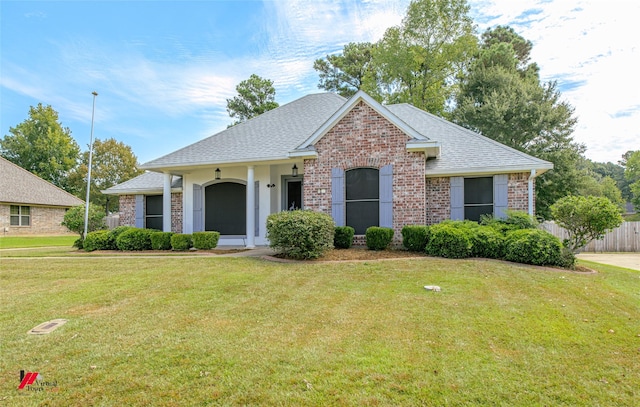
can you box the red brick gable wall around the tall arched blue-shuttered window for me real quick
[304,102,426,243]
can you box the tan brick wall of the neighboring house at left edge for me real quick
[0,204,73,236]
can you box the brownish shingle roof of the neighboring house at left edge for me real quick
[0,157,84,207]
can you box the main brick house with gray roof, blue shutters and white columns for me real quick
[103,91,553,247]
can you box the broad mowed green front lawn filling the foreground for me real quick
[0,257,640,406]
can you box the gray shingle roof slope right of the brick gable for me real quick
[386,103,553,175]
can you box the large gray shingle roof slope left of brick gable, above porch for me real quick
[140,93,346,170]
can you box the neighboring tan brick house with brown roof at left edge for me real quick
[0,157,84,236]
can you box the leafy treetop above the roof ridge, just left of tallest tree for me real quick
[313,42,374,98]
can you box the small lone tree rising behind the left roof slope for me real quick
[227,74,279,126]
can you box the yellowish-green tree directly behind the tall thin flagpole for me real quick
[67,138,143,213]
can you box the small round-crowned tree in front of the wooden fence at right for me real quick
[551,195,622,253]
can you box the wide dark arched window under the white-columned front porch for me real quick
[204,182,247,236]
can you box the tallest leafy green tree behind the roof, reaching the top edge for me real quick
[369,0,477,115]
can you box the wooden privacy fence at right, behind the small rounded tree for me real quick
[540,222,640,252]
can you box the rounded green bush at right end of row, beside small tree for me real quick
[505,229,564,266]
